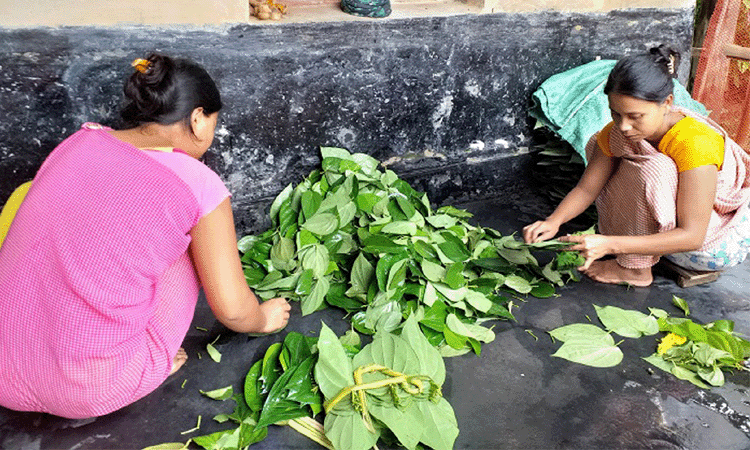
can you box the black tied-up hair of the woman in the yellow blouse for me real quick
[604,44,680,103]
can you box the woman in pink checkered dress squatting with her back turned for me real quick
[0,54,290,418]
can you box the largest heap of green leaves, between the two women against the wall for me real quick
[238,147,580,356]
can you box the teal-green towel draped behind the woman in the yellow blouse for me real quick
[529,59,706,161]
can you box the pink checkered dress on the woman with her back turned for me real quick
[0,124,229,418]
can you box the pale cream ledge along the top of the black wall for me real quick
[0,0,695,28]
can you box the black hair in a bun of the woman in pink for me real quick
[120,53,221,130]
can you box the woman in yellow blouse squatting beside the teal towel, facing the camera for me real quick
[523,45,750,286]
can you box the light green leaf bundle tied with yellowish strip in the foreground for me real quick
[315,317,458,450]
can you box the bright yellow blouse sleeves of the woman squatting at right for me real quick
[596,117,724,172]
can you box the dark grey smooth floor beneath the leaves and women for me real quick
[0,196,750,450]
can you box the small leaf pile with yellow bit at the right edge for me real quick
[643,310,750,389]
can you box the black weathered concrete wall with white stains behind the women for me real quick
[0,7,693,234]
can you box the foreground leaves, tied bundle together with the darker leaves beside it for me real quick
[166,317,458,450]
